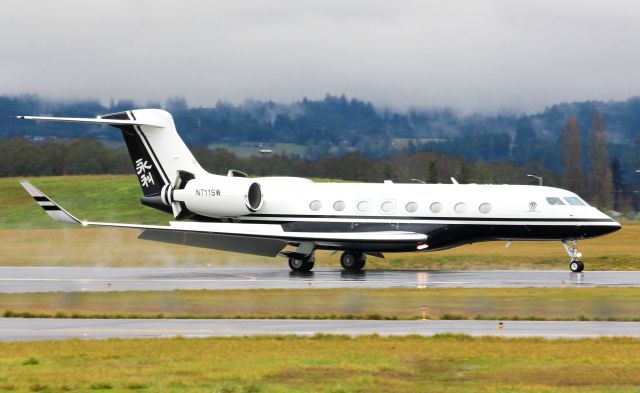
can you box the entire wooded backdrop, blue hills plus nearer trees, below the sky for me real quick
[0,95,640,210]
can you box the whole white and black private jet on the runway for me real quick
[18,109,620,272]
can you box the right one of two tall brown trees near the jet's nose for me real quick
[589,112,613,209]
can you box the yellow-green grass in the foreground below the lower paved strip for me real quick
[0,335,640,393]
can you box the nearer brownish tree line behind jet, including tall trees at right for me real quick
[0,128,638,211]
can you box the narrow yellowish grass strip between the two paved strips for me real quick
[5,287,640,321]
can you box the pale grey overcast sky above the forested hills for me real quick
[0,0,640,112]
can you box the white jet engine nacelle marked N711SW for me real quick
[173,175,264,217]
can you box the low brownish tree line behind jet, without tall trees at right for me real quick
[0,138,559,184]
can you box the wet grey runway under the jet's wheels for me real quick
[0,267,640,292]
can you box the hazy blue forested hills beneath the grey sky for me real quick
[0,95,640,170]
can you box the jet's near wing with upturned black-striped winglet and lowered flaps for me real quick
[20,180,427,256]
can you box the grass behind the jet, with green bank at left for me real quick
[0,175,640,270]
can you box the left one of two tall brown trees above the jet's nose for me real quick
[562,115,585,195]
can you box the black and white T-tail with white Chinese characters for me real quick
[18,109,205,201]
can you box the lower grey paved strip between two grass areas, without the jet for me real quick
[0,318,640,341]
